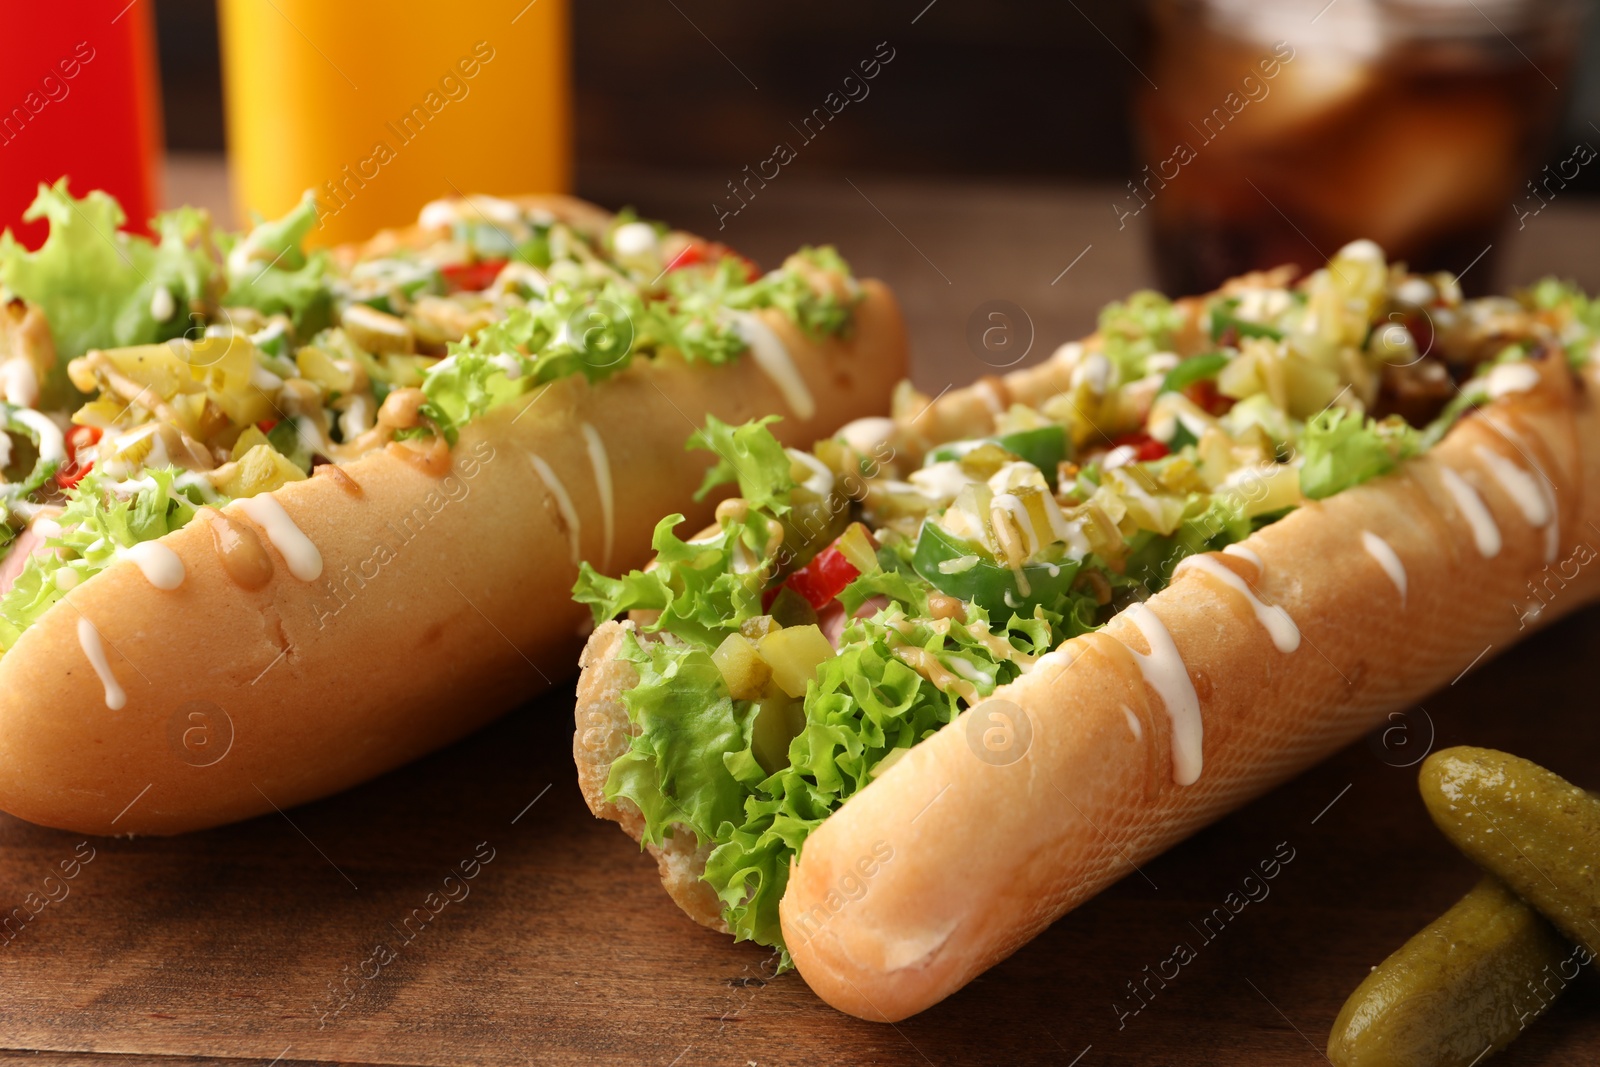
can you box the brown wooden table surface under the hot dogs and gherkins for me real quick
[0,166,1600,1067]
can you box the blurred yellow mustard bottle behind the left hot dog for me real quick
[219,0,571,245]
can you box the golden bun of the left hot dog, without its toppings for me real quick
[0,199,906,833]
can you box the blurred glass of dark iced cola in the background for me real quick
[1139,0,1600,293]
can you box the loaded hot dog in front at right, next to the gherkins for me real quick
[574,242,1600,1021]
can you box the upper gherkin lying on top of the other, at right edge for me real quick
[1421,747,1600,955]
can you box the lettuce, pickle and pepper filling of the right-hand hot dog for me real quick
[574,243,1600,960]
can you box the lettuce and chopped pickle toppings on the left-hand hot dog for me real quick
[0,179,859,653]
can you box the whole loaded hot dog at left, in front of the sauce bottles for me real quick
[0,184,906,833]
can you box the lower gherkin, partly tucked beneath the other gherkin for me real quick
[1328,877,1571,1067]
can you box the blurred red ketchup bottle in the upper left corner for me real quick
[0,0,162,246]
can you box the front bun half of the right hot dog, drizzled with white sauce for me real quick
[781,354,1600,1021]
